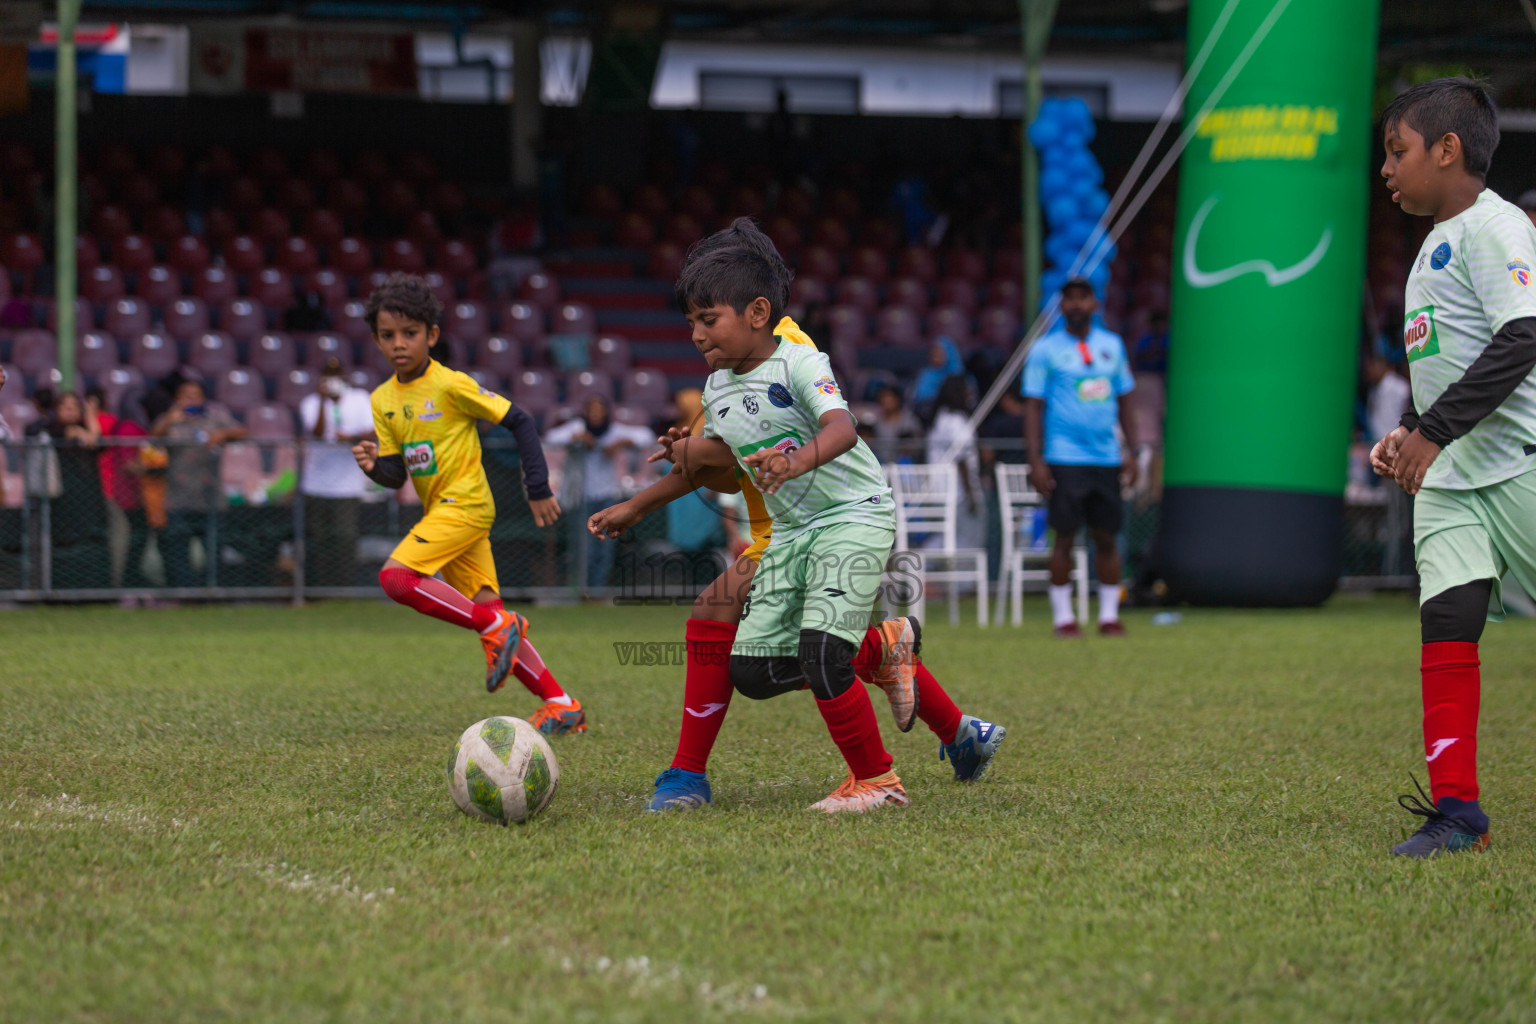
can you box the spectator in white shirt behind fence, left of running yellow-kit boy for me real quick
[298,356,373,586]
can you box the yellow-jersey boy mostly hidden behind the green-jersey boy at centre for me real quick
[588,221,1006,811]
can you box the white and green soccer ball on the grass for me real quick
[449,715,561,824]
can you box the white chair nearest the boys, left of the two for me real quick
[885,462,988,626]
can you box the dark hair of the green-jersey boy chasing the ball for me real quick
[676,216,794,325]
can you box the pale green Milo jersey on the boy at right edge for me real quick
[1402,189,1536,490]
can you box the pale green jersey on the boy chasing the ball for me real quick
[702,339,895,540]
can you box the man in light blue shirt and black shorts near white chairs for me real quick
[1023,278,1137,637]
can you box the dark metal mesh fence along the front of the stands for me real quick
[0,434,1416,602]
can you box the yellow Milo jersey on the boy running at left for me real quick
[373,361,511,527]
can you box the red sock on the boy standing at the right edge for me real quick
[1419,640,1481,800]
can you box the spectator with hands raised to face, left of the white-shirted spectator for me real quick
[149,378,246,586]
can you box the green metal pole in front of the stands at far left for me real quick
[54,0,81,391]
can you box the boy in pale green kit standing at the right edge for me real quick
[1372,78,1536,857]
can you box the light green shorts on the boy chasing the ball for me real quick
[731,522,895,657]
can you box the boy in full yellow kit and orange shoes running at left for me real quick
[352,273,587,734]
